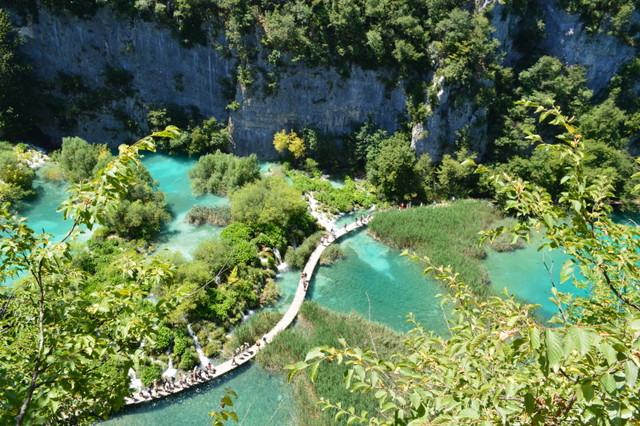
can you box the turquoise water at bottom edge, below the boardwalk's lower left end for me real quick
[101,364,300,426]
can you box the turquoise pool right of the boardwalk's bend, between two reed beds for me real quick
[309,229,446,333]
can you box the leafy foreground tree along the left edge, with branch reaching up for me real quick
[0,129,180,425]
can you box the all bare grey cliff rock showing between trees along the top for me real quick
[7,0,634,159]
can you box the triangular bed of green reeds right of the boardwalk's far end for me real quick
[369,200,504,295]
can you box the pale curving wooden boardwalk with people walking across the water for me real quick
[125,221,367,405]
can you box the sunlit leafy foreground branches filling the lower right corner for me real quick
[289,103,640,424]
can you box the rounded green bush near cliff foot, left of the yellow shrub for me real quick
[189,151,260,195]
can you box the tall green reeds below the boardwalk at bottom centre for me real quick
[257,302,405,426]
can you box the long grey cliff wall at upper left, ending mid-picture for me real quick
[12,9,405,158]
